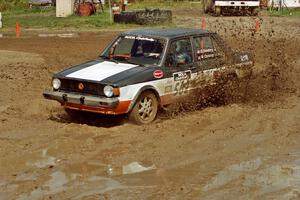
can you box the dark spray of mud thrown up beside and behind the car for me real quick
[161,29,300,118]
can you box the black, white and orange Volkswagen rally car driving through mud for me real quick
[43,28,253,124]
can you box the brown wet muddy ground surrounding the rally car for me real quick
[0,13,300,200]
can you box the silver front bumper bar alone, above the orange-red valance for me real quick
[43,90,119,108]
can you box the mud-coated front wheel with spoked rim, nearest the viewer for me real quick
[129,91,158,124]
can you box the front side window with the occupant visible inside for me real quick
[166,39,193,67]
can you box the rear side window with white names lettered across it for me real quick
[193,36,216,61]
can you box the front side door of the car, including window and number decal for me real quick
[164,37,196,97]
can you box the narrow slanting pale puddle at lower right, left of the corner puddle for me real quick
[202,158,262,191]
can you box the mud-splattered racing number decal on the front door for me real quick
[173,70,192,96]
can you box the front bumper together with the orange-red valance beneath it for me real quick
[43,90,131,114]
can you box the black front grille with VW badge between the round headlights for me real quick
[60,79,104,96]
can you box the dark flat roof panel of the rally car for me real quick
[122,28,210,39]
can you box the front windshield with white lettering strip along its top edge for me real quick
[102,35,166,65]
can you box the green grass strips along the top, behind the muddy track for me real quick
[0,0,300,32]
